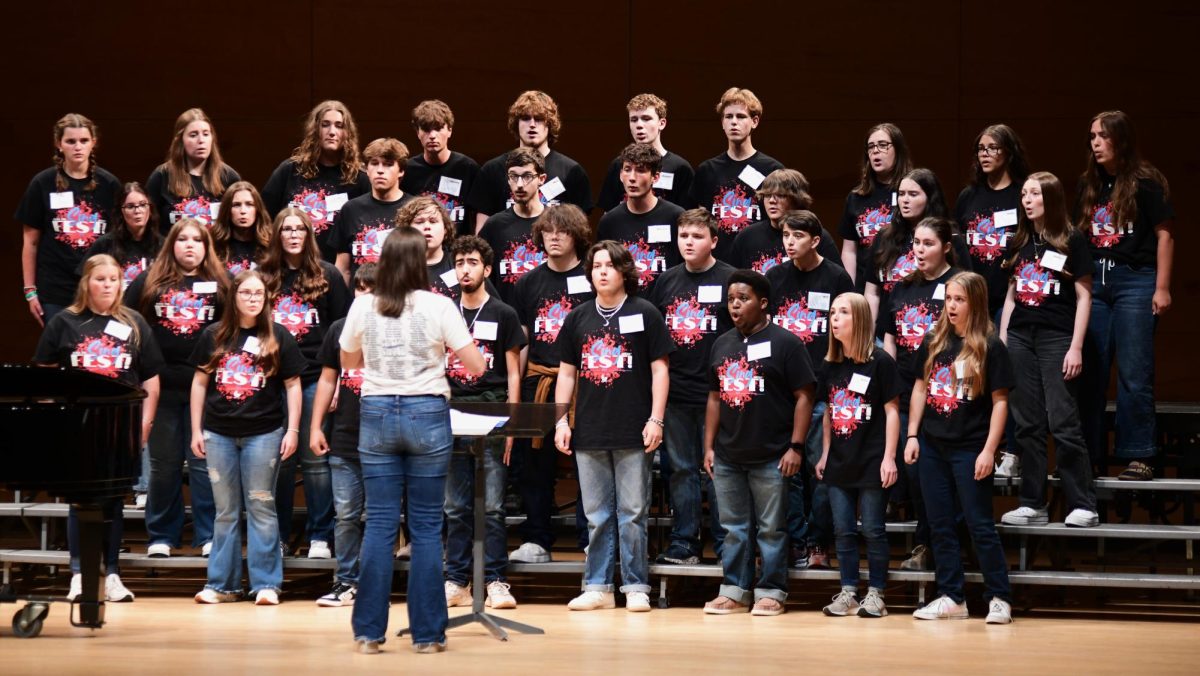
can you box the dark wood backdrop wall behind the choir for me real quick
[0,0,1200,400]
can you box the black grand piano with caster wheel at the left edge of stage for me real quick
[0,365,145,638]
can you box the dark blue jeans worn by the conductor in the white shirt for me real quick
[350,395,454,644]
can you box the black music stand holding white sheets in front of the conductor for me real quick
[396,401,568,641]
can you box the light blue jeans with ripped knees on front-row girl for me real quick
[204,427,283,593]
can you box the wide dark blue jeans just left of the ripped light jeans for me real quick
[146,389,216,548]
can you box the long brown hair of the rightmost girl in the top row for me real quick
[1079,110,1171,234]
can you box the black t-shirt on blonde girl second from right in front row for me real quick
[817,349,912,489]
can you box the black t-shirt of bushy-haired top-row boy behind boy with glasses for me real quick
[467,150,592,216]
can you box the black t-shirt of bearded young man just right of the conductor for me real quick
[446,298,526,396]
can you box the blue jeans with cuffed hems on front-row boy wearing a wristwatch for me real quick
[713,455,787,604]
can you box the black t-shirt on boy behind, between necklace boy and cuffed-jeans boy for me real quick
[649,261,733,406]
